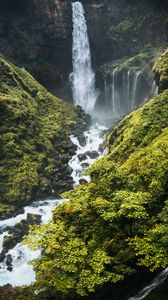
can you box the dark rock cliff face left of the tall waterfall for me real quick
[0,0,71,95]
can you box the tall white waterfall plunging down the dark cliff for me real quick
[70,2,97,113]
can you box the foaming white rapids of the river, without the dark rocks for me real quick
[0,124,107,286]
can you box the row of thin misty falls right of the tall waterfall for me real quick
[104,68,158,118]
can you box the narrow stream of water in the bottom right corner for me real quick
[128,268,168,300]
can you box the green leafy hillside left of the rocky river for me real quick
[0,55,87,217]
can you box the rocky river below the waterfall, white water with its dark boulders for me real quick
[0,124,106,286]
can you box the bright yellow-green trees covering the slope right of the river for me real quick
[26,49,168,299]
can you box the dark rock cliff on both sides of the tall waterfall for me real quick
[0,0,168,95]
